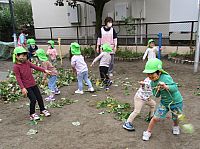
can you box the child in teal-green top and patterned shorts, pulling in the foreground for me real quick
[142,58,183,141]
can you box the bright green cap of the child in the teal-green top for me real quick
[143,58,168,74]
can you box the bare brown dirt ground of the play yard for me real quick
[0,60,200,149]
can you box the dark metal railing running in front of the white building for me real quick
[0,21,197,46]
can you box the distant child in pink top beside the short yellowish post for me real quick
[47,40,58,66]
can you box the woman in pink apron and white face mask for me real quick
[97,17,117,76]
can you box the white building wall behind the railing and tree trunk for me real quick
[31,0,197,39]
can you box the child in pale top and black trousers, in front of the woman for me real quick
[91,43,112,90]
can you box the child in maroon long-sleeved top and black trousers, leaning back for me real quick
[13,47,50,120]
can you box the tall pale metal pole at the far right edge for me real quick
[194,0,200,72]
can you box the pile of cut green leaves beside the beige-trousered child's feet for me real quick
[96,97,131,121]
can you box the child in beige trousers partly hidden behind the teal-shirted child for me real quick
[123,77,156,131]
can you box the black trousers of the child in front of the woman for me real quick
[99,66,110,87]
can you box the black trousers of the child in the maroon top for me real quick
[27,85,45,115]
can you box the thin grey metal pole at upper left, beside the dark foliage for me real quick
[9,0,17,47]
